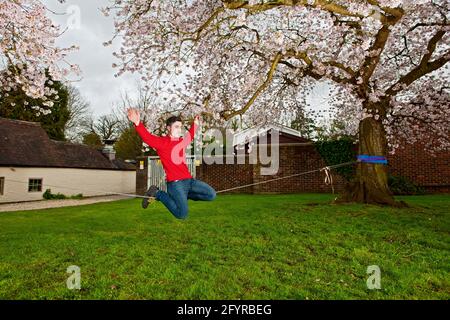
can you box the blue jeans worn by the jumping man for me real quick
[156,178,216,219]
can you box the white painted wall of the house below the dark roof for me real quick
[0,167,136,203]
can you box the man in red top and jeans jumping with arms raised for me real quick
[127,108,216,219]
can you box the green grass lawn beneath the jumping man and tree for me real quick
[0,194,450,299]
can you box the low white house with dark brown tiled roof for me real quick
[0,118,136,203]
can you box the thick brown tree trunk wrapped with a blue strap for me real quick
[336,117,405,206]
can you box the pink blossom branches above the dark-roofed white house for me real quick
[0,0,79,107]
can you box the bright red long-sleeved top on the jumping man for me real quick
[133,122,198,182]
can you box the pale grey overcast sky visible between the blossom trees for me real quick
[43,0,327,122]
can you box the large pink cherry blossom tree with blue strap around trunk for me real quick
[103,0,450,205]
